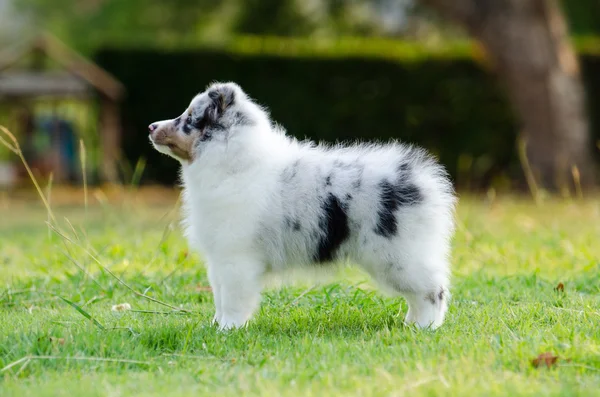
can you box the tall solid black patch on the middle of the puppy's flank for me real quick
[315,193,350,262]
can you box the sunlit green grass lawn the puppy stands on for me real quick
[0,190,600,397]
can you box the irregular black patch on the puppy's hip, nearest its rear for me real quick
[374,179,423,238]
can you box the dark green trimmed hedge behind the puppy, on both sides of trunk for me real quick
[95,38,600,188]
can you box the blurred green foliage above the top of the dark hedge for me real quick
[9,0,600,51]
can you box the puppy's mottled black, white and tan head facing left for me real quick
[148,83,261,164]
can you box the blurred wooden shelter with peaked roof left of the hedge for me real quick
[0,34,125,182]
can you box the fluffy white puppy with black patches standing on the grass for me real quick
[149,83,456,329]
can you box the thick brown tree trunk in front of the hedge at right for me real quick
[422,0,594,190]
